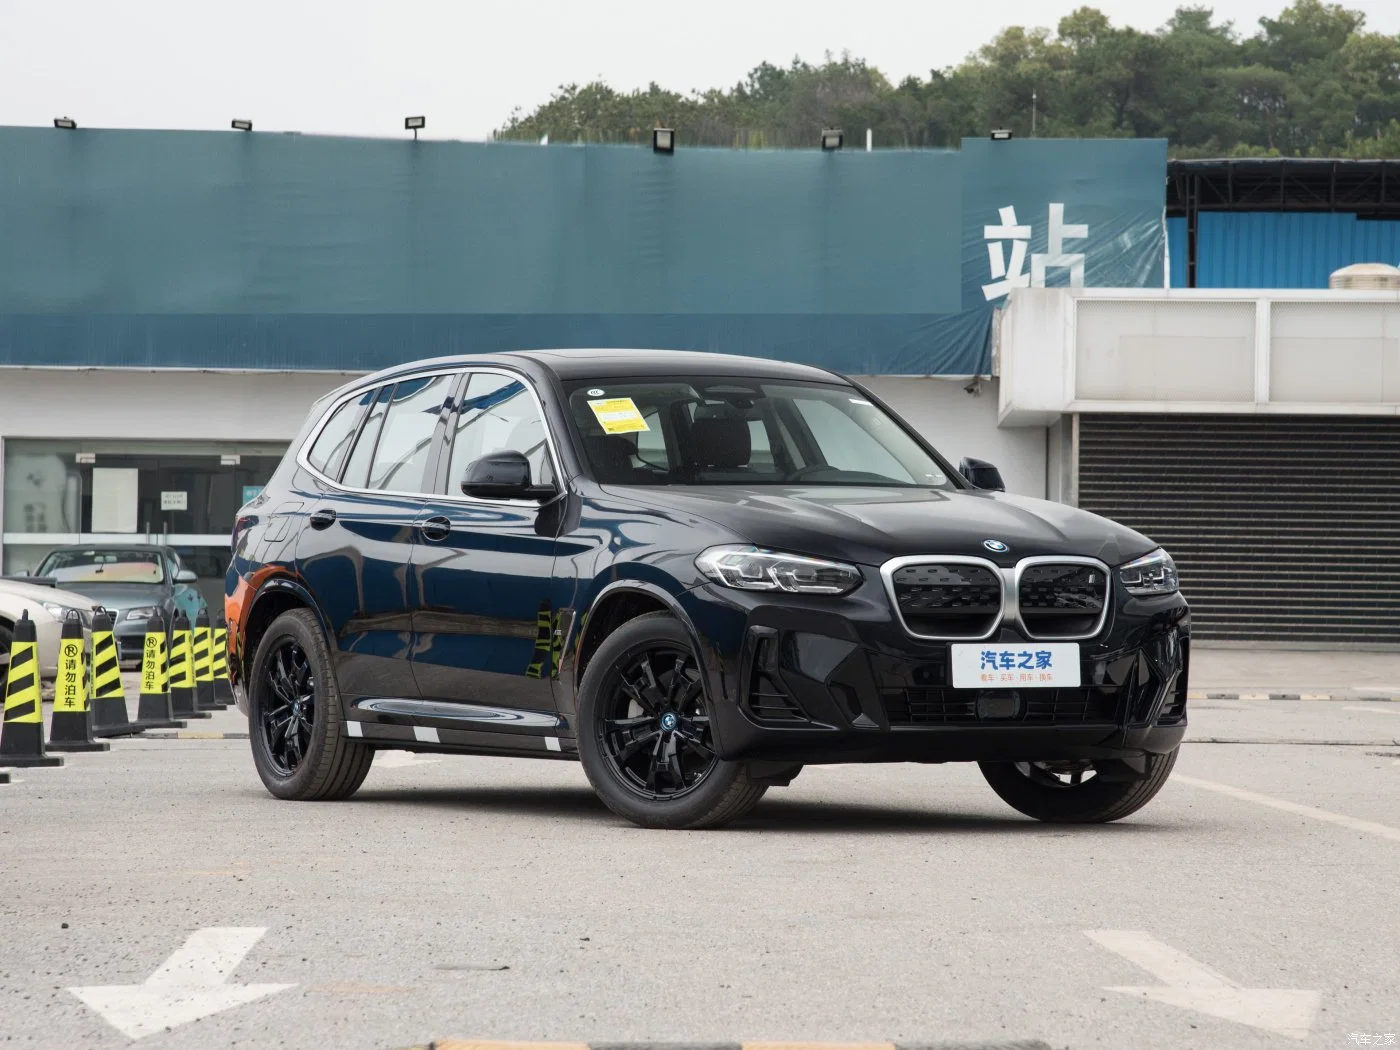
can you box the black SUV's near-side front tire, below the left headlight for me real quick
[578,613,767,829]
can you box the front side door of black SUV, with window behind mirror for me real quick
[413,370,560,724]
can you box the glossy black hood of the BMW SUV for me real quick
[606,486,1156,566]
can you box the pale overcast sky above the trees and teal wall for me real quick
[0,0,1400,142]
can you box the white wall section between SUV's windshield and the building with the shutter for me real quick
[860,375,1046,498]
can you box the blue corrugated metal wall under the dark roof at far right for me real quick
[1168,211,1400,288]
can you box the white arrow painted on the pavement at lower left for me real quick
[69,925,297,1039]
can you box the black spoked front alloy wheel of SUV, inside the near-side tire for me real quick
[595,643,718,801]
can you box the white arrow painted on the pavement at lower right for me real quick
[1085,930,1322,1039]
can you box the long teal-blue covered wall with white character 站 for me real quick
[0,129,1166,375]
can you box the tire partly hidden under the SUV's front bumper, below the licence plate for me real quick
[979,748,1180,825]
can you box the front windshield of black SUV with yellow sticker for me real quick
[568,377,955,489]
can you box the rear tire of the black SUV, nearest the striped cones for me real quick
[248,609,374,802]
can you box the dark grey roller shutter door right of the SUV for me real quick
[1078,414,1400,645]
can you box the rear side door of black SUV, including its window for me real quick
[295,372,459,699]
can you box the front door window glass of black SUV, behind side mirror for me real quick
[447,372,554,496]
